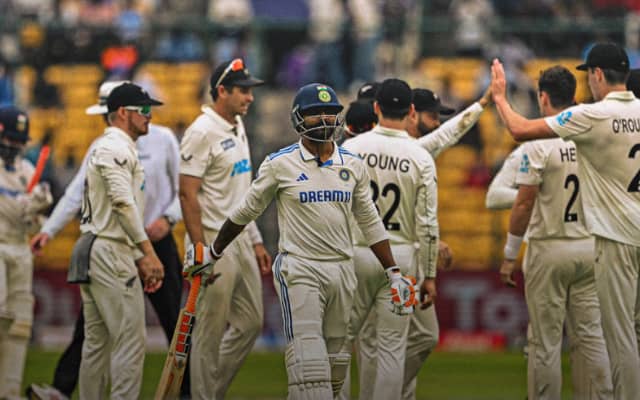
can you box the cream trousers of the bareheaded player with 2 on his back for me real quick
[523,238,613,400]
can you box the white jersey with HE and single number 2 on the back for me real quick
[516,138,591,239]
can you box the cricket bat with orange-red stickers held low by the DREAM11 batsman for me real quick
[154,275,202,400]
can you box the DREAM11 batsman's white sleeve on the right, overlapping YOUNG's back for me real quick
[351,165,389,246]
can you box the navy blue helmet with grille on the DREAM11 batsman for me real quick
[291,83,344,142]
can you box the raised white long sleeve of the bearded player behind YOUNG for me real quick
[418,102,483,158]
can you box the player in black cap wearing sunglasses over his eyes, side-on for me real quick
[76,83,164,399]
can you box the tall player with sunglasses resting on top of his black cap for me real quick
[180,59,271,400]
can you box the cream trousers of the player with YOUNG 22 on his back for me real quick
[340,243,419,400]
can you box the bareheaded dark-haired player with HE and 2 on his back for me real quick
[500,66,613,399]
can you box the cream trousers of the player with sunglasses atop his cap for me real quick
[189,230,263,400]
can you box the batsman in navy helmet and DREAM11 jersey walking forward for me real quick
[185,83,415,400]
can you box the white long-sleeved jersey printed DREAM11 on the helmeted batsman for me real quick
[229,142,388,261]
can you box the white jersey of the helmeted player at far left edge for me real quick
[0,156,35,244]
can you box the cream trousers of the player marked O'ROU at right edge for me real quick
[594,236,640,400]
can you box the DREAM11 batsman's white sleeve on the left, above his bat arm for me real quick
[229,158,278,225]
